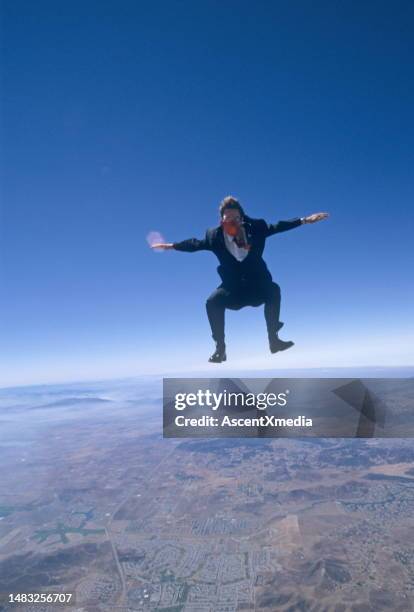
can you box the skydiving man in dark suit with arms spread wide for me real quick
[152,196,328,363]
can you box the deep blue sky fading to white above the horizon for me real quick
[0,0,414,386]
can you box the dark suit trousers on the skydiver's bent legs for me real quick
[206,282,281,345]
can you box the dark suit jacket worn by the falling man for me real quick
[174,216,301,293]
